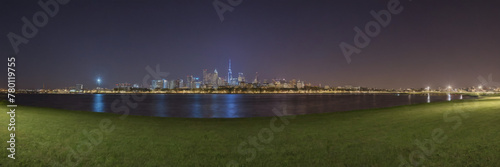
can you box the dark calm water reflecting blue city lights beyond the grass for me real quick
[16,94,469,118]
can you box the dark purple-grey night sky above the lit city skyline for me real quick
[0,0,500,89]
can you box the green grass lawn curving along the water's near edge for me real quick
[0,97,500,167]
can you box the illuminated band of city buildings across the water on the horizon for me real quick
[4,59,498,90]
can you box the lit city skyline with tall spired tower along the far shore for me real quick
[17,59,500,91]
